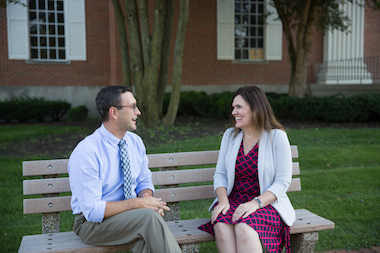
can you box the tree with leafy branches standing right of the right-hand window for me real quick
[273,0,380,97]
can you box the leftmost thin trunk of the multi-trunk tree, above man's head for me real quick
[112,0,132,87]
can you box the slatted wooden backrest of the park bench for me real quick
[22,146,301,214]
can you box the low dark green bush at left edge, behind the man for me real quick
[0,96,71,122]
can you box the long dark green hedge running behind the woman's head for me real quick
[164,91,380,122]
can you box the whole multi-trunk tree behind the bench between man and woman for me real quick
[112,0,189,126]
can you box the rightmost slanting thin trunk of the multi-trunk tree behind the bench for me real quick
[162,0,189,125]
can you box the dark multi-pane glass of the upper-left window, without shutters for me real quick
[28,0,66,61]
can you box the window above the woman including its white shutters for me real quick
[217,0,282,62]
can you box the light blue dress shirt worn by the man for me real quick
[68,125,154,223]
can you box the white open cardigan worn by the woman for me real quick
[209,128,296,226]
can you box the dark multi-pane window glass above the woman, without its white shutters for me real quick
[235,0,264,60]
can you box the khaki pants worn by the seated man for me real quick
[74,209,181,253]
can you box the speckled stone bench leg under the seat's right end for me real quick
[290,232,319,253]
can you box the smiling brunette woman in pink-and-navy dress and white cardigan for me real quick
[199,86,295,253]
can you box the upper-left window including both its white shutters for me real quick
[7,0,87,62]
